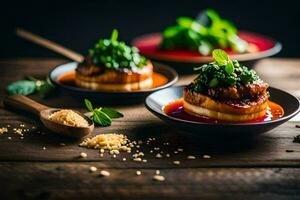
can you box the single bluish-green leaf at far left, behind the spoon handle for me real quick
[6,80,36,96]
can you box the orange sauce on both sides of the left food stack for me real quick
[58,72,168,88]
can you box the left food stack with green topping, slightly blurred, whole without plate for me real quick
[75,30,153,91]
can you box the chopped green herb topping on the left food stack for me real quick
[89,29,147,69]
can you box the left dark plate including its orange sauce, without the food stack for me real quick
[49,62,178,104]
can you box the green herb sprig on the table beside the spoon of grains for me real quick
[84,99,124,126]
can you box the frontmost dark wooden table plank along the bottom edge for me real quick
[0,162,300,200]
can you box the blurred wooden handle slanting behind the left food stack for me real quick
[16,28,84,62]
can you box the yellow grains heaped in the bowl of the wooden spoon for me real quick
[49,109,89,127]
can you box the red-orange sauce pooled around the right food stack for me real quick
[163,98,284,124]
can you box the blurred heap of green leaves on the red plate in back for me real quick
[160,9,248,55]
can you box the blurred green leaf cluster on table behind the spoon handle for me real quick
[6,76,54,98]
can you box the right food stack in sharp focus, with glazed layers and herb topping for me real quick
[183,49,269,122]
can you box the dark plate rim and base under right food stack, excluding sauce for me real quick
[145,86,300,136]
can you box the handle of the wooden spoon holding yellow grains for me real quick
[3,95,49,116]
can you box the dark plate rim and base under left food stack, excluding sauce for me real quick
[49,62,178,104]
